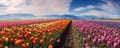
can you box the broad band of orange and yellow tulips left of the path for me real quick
[0,20,70,48]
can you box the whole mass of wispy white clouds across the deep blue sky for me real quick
[74,0,120,18]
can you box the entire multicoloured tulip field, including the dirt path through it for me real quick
[0,19,120,48]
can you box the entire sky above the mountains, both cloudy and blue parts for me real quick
[0,0,120,19]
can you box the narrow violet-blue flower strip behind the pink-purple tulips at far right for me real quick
[90,21,120,29]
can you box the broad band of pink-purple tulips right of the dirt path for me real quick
[73,20,120,48]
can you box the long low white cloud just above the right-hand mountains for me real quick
[80,10,120,19]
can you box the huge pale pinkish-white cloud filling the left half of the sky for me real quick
[0,0,72,16]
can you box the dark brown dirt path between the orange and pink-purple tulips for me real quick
[55,21,79,48]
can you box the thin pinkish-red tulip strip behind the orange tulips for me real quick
[0,20,55,28]
